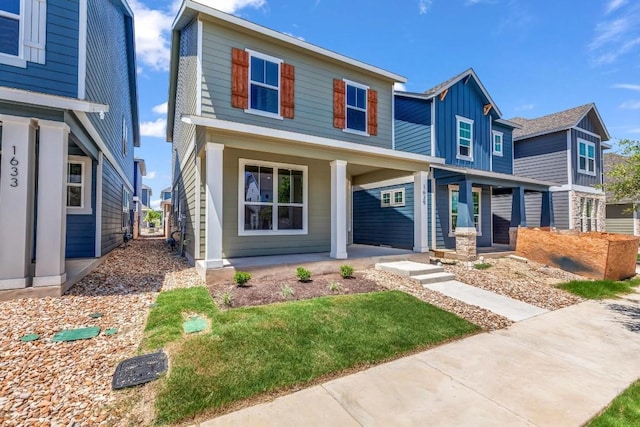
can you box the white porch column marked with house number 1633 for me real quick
[0,115,36,289]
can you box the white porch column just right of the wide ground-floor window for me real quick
[329,160,347,259]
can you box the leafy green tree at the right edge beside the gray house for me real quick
[604,139,640,206]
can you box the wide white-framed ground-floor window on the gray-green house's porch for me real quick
[238,160,307,235]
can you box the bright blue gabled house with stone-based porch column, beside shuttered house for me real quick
[353,69,554,256]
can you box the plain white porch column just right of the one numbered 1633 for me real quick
[33,120,69,286]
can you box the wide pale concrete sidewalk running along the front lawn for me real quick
[200,299,640,427]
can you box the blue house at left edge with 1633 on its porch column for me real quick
[0,0,140,295]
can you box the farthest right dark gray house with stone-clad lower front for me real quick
[502,104,611,231]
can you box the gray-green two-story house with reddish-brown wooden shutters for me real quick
[167,0,442,277]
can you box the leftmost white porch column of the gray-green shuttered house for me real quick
[206,142,224,269]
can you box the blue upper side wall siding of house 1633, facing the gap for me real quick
[86,0,135,184]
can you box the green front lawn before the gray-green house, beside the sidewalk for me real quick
[142,288,479,423]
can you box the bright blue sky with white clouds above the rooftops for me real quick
[129,0,640,207]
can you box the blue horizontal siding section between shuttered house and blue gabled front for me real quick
[394,96,431,155]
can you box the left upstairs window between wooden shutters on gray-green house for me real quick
[249,52,282,116]
